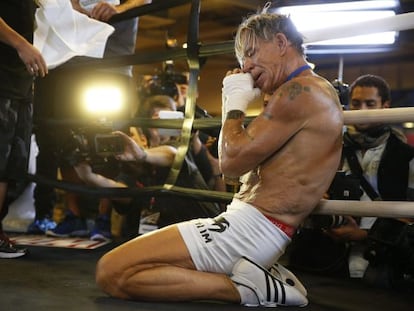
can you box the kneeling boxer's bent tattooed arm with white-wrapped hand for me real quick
[219,70,310,178]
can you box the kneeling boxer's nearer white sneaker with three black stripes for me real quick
[231,257,308,307]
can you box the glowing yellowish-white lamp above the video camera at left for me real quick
[83,86,123,115]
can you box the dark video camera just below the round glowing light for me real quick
[58,128,124,166]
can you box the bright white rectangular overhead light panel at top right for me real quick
[276,1,398,45]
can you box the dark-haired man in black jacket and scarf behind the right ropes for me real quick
[290,75,414,287]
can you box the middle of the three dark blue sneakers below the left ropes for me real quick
[46,214,89,238]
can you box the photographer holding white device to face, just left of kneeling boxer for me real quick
[133,95,220,226]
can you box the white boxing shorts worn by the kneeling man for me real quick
[177,199,291,275]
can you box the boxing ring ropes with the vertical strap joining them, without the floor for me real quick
[29,0,414,222]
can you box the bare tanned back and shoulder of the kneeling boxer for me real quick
[236,73,343,227]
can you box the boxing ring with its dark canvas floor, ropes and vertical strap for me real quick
[4,0,414,311]
